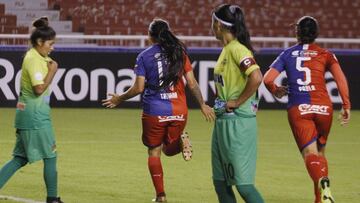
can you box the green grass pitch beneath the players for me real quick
[0,108,360,203]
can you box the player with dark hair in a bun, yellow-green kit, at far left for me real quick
[0,17,62,203]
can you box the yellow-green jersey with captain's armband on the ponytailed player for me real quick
[214,39,259,117]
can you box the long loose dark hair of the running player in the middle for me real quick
[149,18,186,89]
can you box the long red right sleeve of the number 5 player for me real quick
[329,63,351,109]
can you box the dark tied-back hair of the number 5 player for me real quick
[296,16,319,44]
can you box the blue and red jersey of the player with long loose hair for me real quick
[134,44,192,116]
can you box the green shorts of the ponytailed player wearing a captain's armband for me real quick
[211,114,257,185]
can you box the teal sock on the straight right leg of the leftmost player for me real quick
[44,157,57,198]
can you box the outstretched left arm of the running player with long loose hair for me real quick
[102,76,145,108]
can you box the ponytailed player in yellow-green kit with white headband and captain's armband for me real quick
[211,4,264,203]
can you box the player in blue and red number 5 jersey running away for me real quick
[264,16,350,203]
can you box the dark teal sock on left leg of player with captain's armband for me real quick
[213,180,236,203]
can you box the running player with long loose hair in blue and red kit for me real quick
[103,19,215,202]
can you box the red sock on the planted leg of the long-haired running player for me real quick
[148,156,165,196]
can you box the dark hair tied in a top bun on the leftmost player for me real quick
[30,16,56,47]
